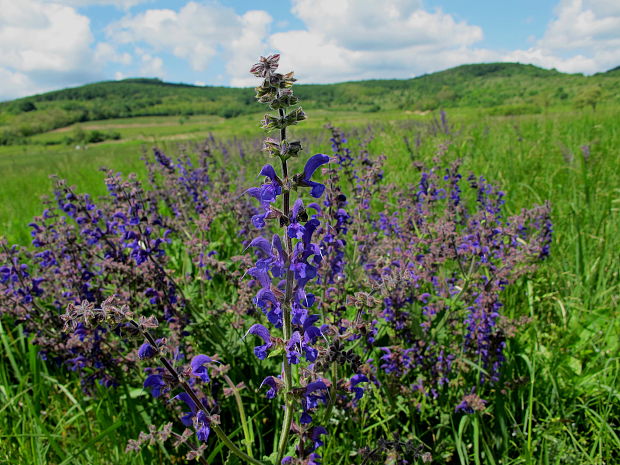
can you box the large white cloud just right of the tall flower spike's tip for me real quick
[260,0,496,82]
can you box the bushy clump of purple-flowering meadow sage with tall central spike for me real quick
[0,55,552,465]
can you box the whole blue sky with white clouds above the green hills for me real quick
[0,0,620,100]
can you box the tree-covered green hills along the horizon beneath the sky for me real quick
[0,63,620,145]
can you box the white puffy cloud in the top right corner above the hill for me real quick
[503,0,620,74]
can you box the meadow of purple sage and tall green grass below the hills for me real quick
[0,55,620,465]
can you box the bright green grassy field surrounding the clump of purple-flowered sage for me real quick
[0,84,620,465]
